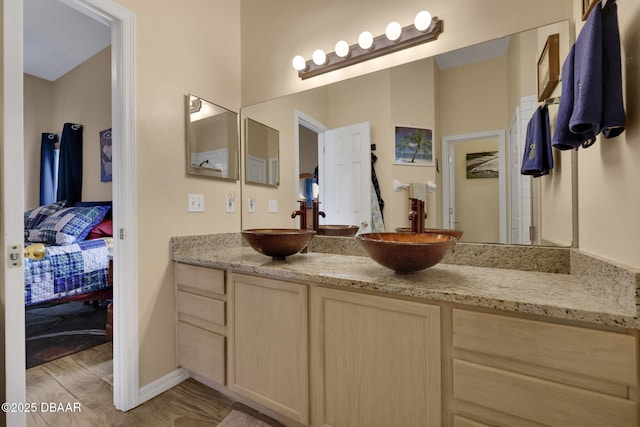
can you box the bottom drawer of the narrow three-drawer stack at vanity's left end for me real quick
[178,322,225,385]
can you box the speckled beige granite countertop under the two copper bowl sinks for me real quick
[172,234,640,329]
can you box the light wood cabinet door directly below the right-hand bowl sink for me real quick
[310,287,442,427]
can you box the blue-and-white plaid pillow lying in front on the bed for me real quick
[27,206,110,245]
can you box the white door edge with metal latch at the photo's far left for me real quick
[0,1,26,426]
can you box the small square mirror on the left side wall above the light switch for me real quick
[186,95,240,181]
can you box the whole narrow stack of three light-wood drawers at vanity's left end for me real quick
[175,263,227,385]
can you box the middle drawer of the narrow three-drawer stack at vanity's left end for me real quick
[178,291,226,330]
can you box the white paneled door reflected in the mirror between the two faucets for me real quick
[318,122,371,233]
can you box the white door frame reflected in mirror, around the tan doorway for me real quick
[442,130,507,243]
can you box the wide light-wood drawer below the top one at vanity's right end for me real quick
[453,360,637,427]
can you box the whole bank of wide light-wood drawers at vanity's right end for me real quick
[453,309,638,427]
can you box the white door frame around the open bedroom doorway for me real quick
[3,0,140,418]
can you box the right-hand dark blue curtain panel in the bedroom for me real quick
[58,123,82,206]
